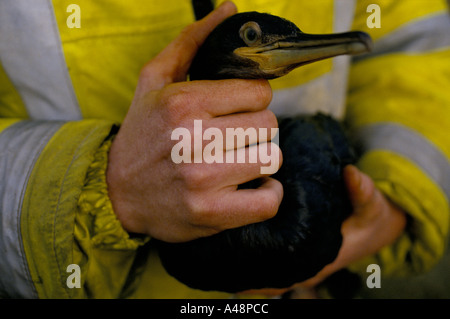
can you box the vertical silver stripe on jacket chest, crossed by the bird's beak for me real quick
[270,0,355,119]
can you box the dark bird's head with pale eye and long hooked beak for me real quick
[190,12,372,80]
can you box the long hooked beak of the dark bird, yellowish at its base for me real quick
[234,31,372,77]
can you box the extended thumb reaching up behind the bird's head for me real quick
[141,1,236,90]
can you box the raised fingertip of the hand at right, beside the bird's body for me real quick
[344,165,375,210]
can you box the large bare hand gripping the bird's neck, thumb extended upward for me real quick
[107,2,283,242]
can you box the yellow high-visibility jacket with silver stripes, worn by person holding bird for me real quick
[0,0,450,298]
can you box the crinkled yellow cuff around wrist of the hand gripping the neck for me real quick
[78,136,150,250]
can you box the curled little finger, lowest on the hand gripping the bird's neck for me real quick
[211,177,283,230]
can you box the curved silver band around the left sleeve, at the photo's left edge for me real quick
[0,121,62,298]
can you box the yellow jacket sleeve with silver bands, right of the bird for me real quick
[346,0,450,275]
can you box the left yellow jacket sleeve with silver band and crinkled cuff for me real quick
[0,118,229,299]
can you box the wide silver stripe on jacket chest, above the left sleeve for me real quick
[0,0,81,120]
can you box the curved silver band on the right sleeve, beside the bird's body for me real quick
[355,123,450,199]
